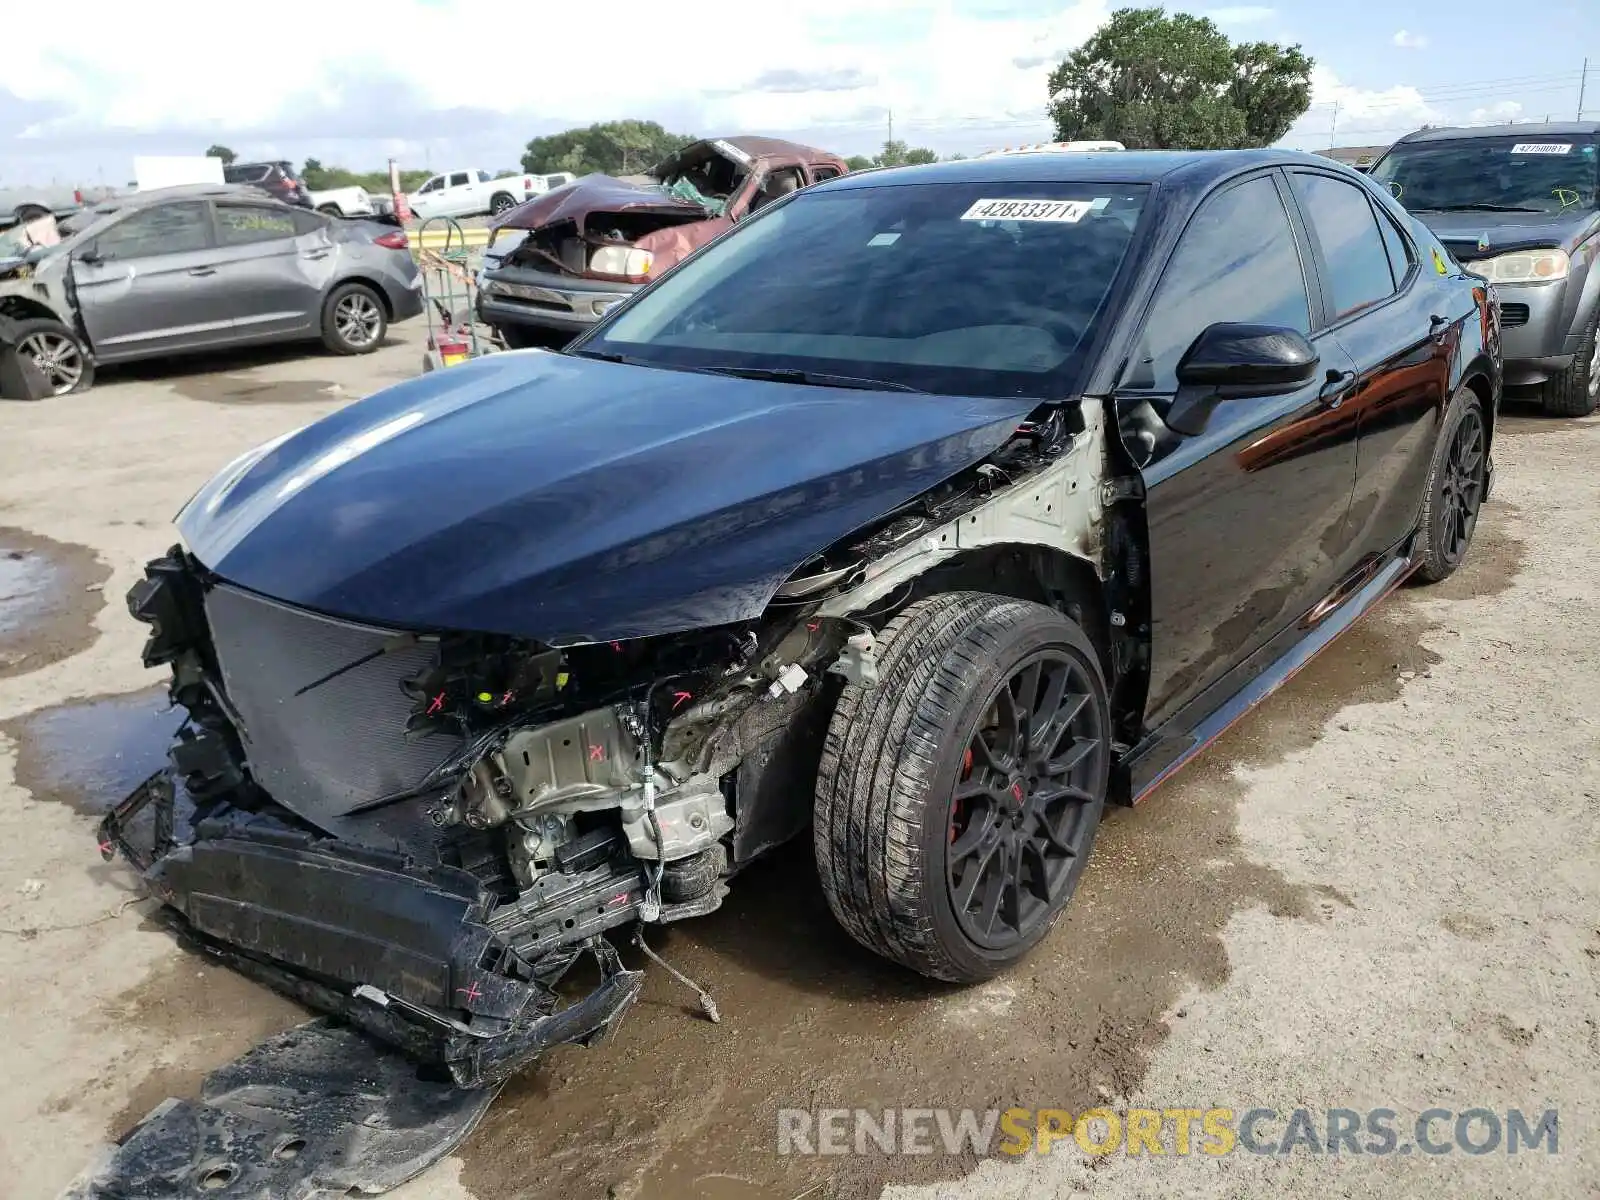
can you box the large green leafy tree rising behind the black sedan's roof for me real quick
[1050,8,1312,150]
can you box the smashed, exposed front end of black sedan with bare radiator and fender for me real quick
[101,400,1141,1086]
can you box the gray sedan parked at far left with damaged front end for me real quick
[0,186,422,395]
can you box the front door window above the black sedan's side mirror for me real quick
[1125,176,1312,392]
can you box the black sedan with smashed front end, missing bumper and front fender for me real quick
[101,150,1501,1085]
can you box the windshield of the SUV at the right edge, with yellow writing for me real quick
[1371,134,1597,213]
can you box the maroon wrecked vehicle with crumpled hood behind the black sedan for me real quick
[478,138,850,347]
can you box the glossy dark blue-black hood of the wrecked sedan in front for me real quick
[178,350,1032,645]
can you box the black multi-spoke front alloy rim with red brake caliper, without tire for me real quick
[946,650,1106,952]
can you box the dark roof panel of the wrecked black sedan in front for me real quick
[821,149,1338,190]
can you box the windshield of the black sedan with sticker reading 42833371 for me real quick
[573,182,1149,397]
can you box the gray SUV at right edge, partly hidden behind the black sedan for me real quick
[1371,122,1600,416]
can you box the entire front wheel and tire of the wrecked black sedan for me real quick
[814,592,1110,982]
